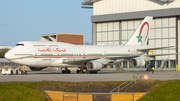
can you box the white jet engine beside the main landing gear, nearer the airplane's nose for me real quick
[86,61,103,71]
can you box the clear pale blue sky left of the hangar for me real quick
[0,0,93,46]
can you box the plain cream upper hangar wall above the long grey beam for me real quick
[93,0,180,15]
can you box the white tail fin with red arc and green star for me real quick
[125,16,153,46]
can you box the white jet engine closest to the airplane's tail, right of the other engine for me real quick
[130,57,146,67]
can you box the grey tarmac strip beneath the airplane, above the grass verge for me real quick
[0,71,180,82]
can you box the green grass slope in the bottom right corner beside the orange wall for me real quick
[138,80,180,101]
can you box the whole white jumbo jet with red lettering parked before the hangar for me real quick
[5,16,177,73]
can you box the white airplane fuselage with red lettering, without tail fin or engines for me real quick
[6,41,148,67]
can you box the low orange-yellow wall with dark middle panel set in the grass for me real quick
[45,90,146,101]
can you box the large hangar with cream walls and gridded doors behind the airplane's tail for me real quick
[81,0,180,70]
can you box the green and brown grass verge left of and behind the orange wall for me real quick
[0,81,122,101]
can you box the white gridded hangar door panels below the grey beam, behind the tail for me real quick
[93,17,176,60]
